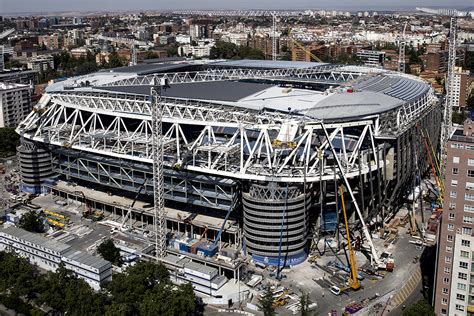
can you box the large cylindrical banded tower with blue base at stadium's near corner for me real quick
[243,183,311,266]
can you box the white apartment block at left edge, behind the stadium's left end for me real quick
[0,82,32,127]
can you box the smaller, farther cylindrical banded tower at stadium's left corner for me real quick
[17,139,54,194]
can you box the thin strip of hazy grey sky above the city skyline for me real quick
[0,0,473,15]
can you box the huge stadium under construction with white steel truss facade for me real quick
[17,60,442,266]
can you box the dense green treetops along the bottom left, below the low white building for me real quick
[0,252,196,315]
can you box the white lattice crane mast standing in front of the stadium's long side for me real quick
[151,79,167,259]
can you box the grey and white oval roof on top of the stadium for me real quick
[47,60,433,121]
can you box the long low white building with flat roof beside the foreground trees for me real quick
[0,226,112,289]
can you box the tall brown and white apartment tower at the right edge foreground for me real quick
[434,121,474,315]
